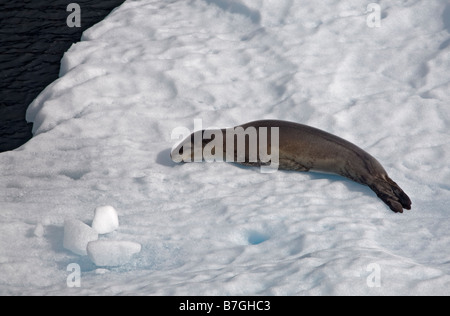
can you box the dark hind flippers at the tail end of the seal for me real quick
[369,175,411,213]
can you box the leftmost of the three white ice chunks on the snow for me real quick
[63,219,98,256]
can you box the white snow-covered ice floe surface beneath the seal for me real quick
[0,0,450,295]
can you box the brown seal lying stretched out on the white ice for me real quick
[171,120,411,213]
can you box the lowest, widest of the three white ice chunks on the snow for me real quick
[87,240,141,267]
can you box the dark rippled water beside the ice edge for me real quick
[0,0,124,152]
